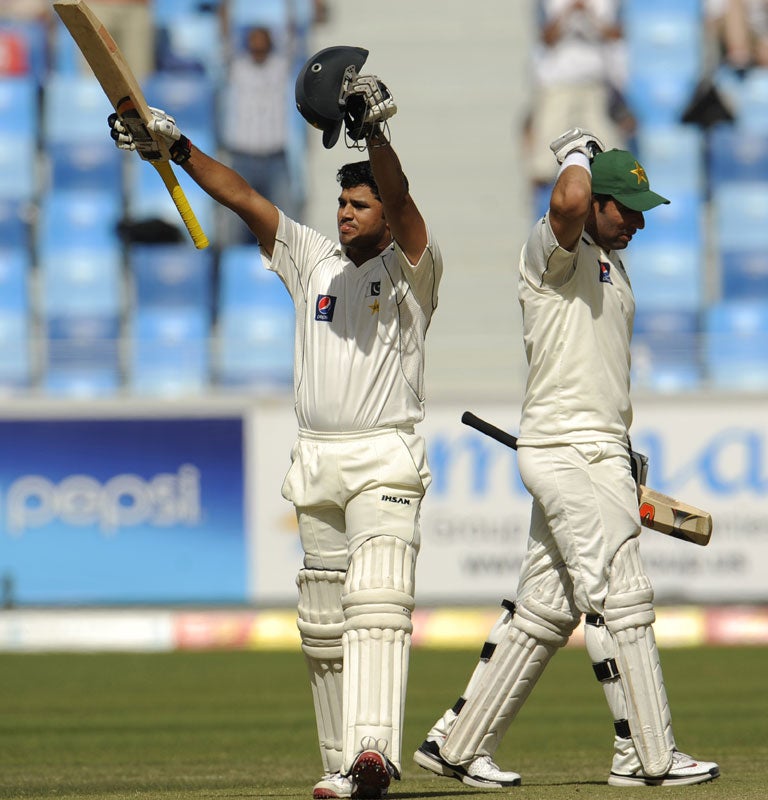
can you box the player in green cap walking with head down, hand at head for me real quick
[414,128,720,788]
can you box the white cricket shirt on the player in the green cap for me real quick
[518,213,635,445]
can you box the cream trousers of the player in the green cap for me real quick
[517,442,640,614]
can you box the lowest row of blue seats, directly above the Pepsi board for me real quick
[0,244,294,396]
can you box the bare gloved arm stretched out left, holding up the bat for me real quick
[109,108,279,255]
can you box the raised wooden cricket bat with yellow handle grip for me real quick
[53,0,208,250]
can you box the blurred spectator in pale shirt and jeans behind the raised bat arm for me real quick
[220,26,301,244]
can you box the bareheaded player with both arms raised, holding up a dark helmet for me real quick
[110,47,443,798]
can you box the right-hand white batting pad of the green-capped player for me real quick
[605,539,675,776]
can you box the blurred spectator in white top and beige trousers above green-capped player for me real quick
[524,0,635,206]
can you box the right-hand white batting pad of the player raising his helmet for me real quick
[342,536,416,772]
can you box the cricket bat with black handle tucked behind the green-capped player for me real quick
[461,411,712,546]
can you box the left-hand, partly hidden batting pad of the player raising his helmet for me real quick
[296,569,345,773]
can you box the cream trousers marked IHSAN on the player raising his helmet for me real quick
[282,426,431,570]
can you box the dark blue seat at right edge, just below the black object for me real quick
[708,125,768,186]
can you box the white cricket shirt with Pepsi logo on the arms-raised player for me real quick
[262,211,443,432]
